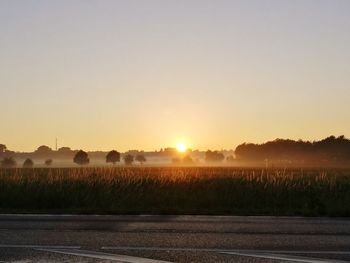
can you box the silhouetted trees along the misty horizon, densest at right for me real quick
[0,135,350,167]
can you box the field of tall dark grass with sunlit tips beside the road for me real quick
[0,167,350,216]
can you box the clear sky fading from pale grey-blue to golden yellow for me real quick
[0,0,350,151]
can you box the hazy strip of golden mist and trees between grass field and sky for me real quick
[0,135,350,168]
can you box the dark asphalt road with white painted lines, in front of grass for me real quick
[0,215,350,263]
